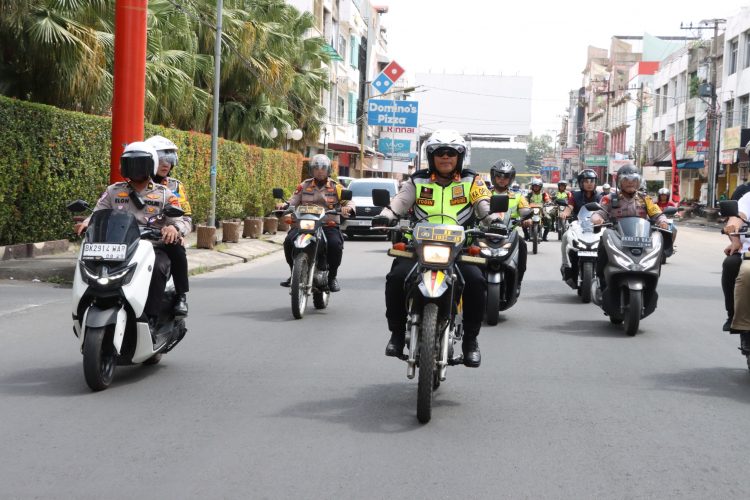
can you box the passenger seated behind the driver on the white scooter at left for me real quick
[145,135,193,316]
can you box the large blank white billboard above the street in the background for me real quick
[410,73,532,135]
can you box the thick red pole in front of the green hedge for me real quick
[109,0,148,183]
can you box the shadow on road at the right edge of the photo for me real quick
[646,368,750,404]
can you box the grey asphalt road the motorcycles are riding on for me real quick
[0,228,750,499]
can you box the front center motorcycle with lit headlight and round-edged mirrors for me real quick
[372,189,508,423]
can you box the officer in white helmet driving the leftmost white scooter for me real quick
[76,142,190,329]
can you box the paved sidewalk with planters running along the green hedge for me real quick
[0,228,286,283]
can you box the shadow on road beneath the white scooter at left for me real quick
[0,363,162,397]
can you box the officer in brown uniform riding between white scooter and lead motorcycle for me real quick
[276,154,355,292]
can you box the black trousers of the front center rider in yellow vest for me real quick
[385,258,487,339]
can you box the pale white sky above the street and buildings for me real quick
[382,0,750,135]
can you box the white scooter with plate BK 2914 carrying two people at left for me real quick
[68,200,187,391]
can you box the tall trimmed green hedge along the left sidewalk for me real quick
[0,96,302,245]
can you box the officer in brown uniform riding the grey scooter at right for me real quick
[591,165,669,290]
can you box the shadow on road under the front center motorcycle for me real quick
[274,383,458,434]
